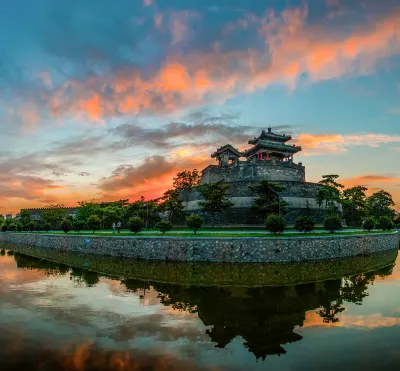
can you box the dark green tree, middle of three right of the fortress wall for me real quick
[342,186,367,227]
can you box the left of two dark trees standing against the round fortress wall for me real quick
[198,180,233,226]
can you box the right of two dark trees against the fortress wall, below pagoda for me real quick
[249,180,288,219]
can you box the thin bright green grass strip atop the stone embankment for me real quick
[11,231,394,238]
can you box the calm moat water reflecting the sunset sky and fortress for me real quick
[0,246,400,371]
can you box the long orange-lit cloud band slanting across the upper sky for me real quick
[33,7,400,121]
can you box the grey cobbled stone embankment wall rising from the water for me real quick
[0,232,399,262]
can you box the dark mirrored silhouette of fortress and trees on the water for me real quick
[150,268,391,360]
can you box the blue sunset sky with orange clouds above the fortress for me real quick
[0,0,400,214]
